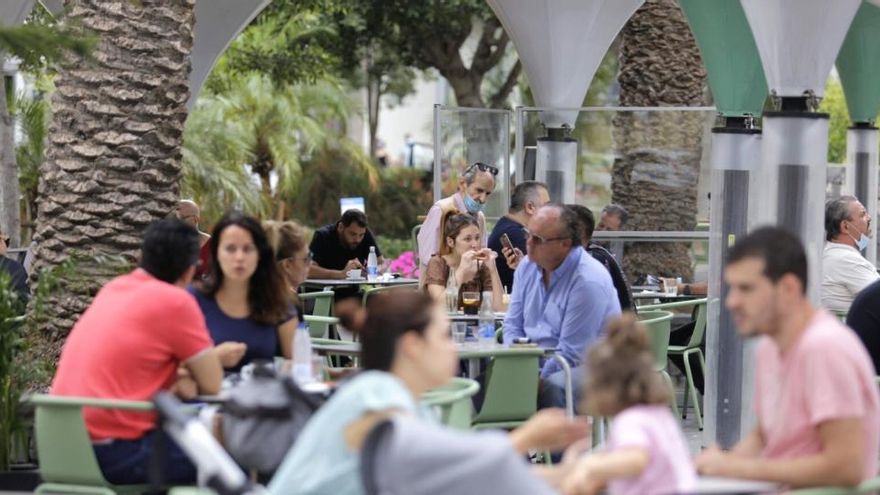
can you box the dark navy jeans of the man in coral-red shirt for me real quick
[94,430,196,485]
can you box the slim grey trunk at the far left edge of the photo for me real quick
[0,63,21,247]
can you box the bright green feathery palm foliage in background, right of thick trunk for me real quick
[184,74,378,222]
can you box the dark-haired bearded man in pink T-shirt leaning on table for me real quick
[696,227,880,487]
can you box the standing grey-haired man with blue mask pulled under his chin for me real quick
[418,162,498,282]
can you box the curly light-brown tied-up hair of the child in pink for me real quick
[582,312,670,416]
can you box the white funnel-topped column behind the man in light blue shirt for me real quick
[486,0,644,203]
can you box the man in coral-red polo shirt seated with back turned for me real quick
[51,219,244,484]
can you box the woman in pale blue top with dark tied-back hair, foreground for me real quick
[269,288,587,495]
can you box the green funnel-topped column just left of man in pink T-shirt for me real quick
[679,0,767,448]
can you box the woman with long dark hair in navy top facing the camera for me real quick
[190,212,299,371]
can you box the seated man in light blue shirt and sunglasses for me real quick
[504,205,620,407]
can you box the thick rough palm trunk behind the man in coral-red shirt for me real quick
[28,0,194,384]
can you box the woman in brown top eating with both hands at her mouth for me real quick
[425,211,504,311]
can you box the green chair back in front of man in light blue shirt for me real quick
[474,347,544,428]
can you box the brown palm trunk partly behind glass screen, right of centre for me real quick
[611,0,706,278]
